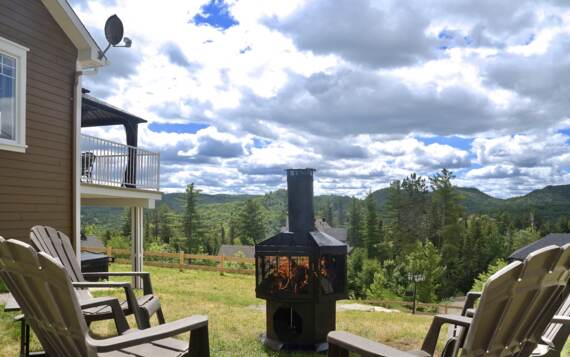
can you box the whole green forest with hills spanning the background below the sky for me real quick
[82,169,570,302]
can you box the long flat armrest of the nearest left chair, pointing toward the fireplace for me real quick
[87,315,208,352]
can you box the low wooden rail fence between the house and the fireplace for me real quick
[81,247,255,274]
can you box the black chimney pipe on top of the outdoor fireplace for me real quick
[287,169,315,232]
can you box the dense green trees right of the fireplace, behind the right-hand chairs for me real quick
[348,169,548,302]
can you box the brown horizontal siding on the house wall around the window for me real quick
[0,0,77,240]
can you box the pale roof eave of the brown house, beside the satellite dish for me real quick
[41,0,107,69]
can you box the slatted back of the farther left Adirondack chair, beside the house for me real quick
[30,226,85,281]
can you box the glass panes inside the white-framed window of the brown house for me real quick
[0,53,16,140]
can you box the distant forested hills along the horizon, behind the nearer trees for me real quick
[81,185,570,234]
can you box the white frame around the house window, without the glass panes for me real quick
[0,37,29,153]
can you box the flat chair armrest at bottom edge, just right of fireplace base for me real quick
[327,331,417,357]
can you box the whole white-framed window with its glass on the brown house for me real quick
[0,37,28,152]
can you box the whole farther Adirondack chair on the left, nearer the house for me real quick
[30,226,164,329]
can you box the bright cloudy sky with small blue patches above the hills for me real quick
[70,0,570,198]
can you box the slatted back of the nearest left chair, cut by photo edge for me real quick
[0,237,97,357]
